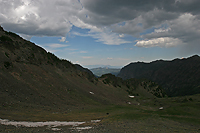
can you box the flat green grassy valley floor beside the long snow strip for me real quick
[2,95,200,133]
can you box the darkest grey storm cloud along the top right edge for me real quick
[81,0,200,28]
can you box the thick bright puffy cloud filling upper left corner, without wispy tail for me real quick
[0,0,77,36]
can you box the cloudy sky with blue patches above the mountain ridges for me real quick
[0,0,200,67]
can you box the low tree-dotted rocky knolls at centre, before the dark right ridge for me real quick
[99,74,167,98]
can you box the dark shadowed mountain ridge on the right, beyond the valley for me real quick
[118,55,200,96]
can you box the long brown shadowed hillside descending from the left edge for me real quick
[0,25,132,113]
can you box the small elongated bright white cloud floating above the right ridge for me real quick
[135,37,182,48]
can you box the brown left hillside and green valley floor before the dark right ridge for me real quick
[0,28,200,133]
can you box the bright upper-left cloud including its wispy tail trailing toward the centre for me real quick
[0,0,133,45]
